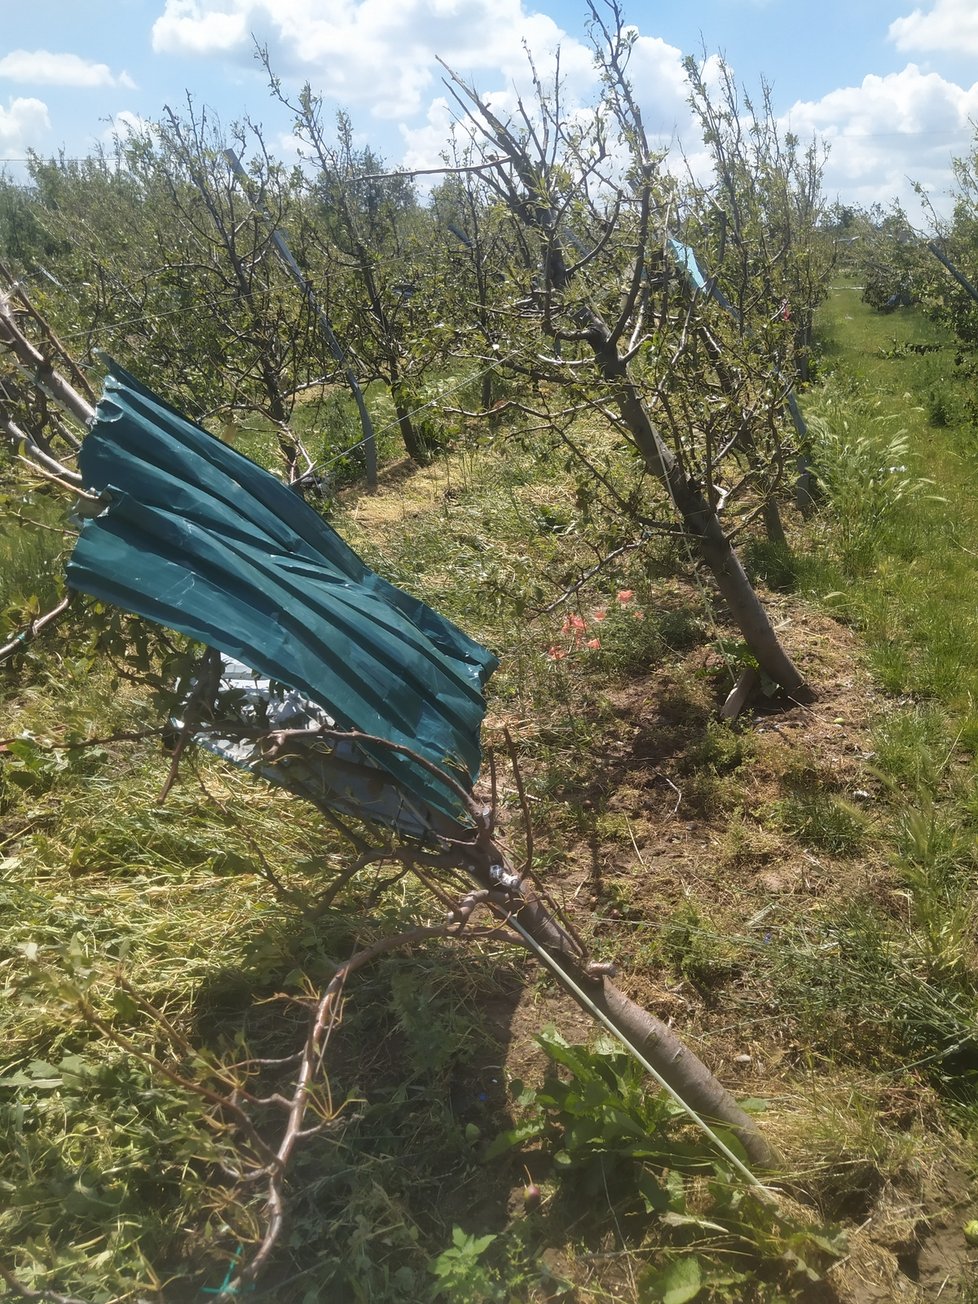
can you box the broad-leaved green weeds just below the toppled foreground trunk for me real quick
[488,1031,844,1301]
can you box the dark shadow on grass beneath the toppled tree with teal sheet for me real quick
[187,900,526,1304]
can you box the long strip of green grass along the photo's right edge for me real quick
[773,289,978,1100]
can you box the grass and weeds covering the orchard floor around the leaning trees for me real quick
[9,291,978,1304]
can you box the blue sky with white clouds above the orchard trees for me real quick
[0,0,978,219]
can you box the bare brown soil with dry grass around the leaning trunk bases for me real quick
[472,595,978,1304]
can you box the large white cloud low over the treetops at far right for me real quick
[785,64,978,211]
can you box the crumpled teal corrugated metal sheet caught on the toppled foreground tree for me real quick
[68,363,498,824]
